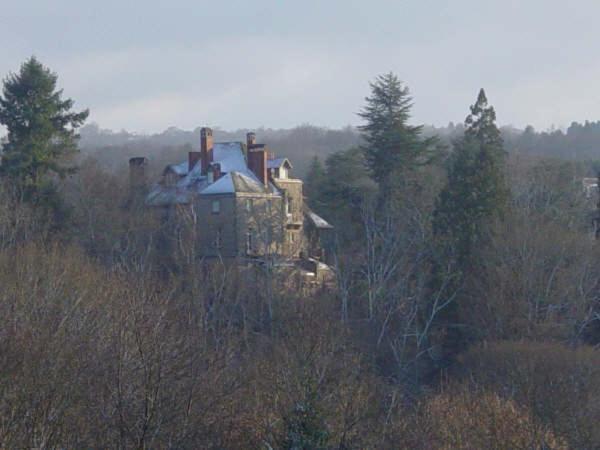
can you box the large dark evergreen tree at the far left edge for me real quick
[0,57,88,207]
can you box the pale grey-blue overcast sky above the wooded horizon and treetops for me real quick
[0,0,600,132]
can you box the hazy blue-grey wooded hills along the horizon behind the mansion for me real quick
[80,122,600,182]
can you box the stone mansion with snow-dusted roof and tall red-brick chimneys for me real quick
[136,128,332,261]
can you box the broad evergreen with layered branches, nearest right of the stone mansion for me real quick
[358,73,436,195]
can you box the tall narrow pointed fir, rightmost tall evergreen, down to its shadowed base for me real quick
[425,89,509,361]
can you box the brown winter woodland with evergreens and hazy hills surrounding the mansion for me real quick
[0,58,600,450]
